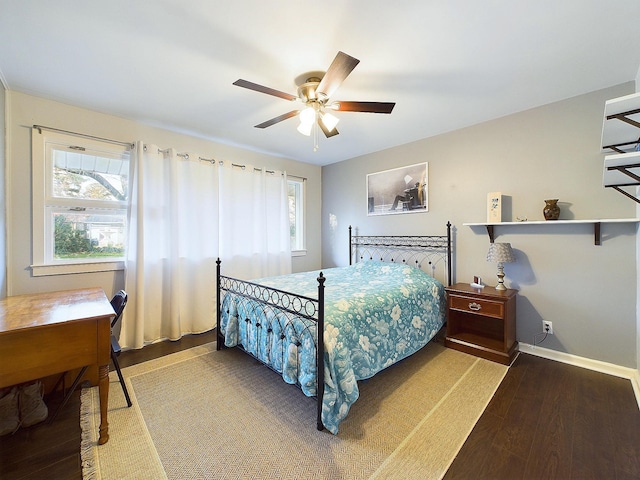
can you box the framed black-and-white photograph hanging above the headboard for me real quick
[367,162,429,216]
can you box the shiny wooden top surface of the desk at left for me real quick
[0,288,115,335]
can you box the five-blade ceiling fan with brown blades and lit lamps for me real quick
[233,52,395,150]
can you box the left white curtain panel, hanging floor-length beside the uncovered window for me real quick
[120,143,218,348]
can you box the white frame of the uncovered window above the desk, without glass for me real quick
[31,128,132,277]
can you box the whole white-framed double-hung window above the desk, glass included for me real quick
[32,129,130,276]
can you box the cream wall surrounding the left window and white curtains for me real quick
[7,92,321,295]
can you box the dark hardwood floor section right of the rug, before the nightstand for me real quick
[445,354,640,480]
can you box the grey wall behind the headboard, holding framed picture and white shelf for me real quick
[322,82,638,368]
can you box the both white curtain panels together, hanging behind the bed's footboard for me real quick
[120,142,291,348]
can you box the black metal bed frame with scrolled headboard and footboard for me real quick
[216,222,452,430]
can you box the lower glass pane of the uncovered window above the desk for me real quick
[53,212,126,260]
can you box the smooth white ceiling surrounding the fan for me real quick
[0,0,640,165]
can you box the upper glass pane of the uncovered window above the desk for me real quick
[52,147,129,202]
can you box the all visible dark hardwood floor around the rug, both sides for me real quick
[0,333,640,480]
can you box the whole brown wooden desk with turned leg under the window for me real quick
[0,288,115,445]
